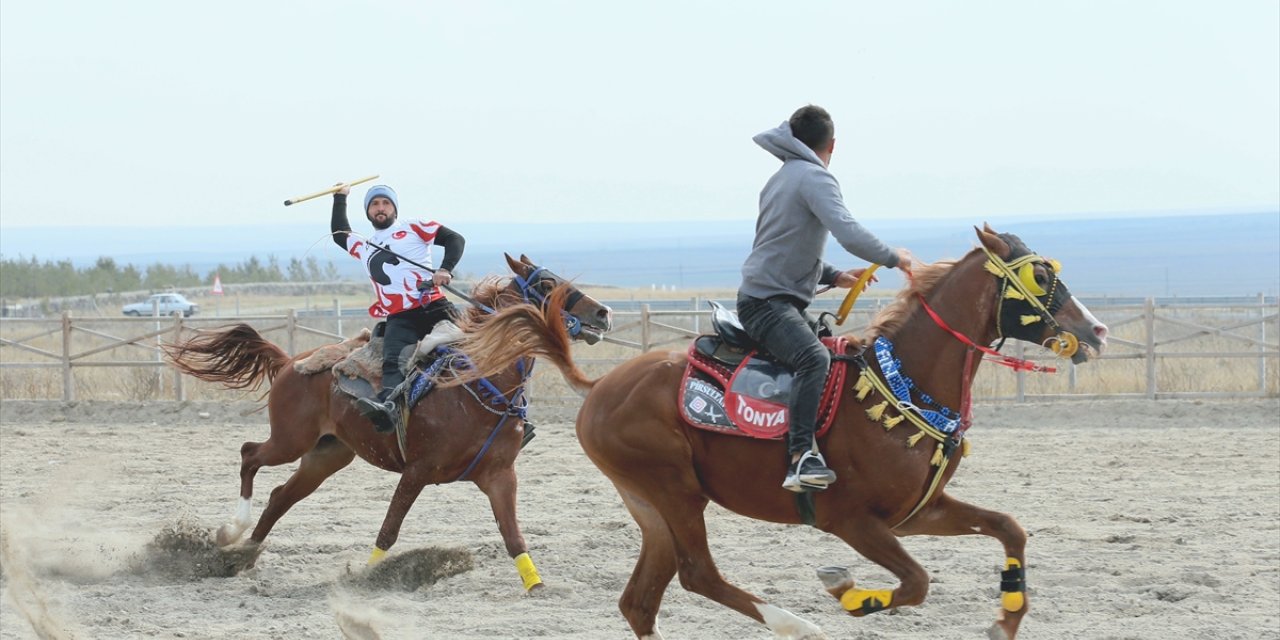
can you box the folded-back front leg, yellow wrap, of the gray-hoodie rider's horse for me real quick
[818,518,929,617]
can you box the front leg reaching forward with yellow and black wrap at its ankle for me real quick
[900,493,1028,640]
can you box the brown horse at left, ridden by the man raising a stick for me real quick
[169,256,611,589]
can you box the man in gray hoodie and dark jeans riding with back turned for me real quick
[737,105,911,492]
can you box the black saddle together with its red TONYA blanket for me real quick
[680,301,850,440]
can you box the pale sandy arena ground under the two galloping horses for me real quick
[0,399,1280,640]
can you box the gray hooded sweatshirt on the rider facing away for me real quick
[739,122,897,306]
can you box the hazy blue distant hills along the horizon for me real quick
[0,211,1280,296]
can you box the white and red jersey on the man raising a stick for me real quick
[347,220,444,317]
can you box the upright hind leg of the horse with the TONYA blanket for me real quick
[618,486,676,640]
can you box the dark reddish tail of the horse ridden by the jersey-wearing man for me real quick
[164,324,293,389]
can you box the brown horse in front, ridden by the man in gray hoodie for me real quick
[450,228,1107,639]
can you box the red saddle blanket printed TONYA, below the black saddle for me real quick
[680,338,849,440]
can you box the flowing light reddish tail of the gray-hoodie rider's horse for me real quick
[440,284,595,396]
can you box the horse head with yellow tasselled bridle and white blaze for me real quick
[974,224,1107,364]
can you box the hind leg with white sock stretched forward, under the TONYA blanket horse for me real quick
[614,476,827,640]
